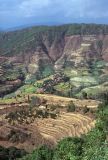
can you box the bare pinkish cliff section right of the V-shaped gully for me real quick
[55,35,102,69]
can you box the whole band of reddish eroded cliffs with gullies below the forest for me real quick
[1,35,108,68]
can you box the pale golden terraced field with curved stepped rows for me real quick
[33,113,95,144]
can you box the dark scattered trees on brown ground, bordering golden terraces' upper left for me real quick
[6,108,58,125]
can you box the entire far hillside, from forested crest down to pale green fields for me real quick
[0,24,108,98]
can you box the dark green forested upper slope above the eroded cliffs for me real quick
[0,24,108,56]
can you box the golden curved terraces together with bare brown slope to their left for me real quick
[0,112,96,152]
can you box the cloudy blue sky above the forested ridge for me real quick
[0,0,108,29]
